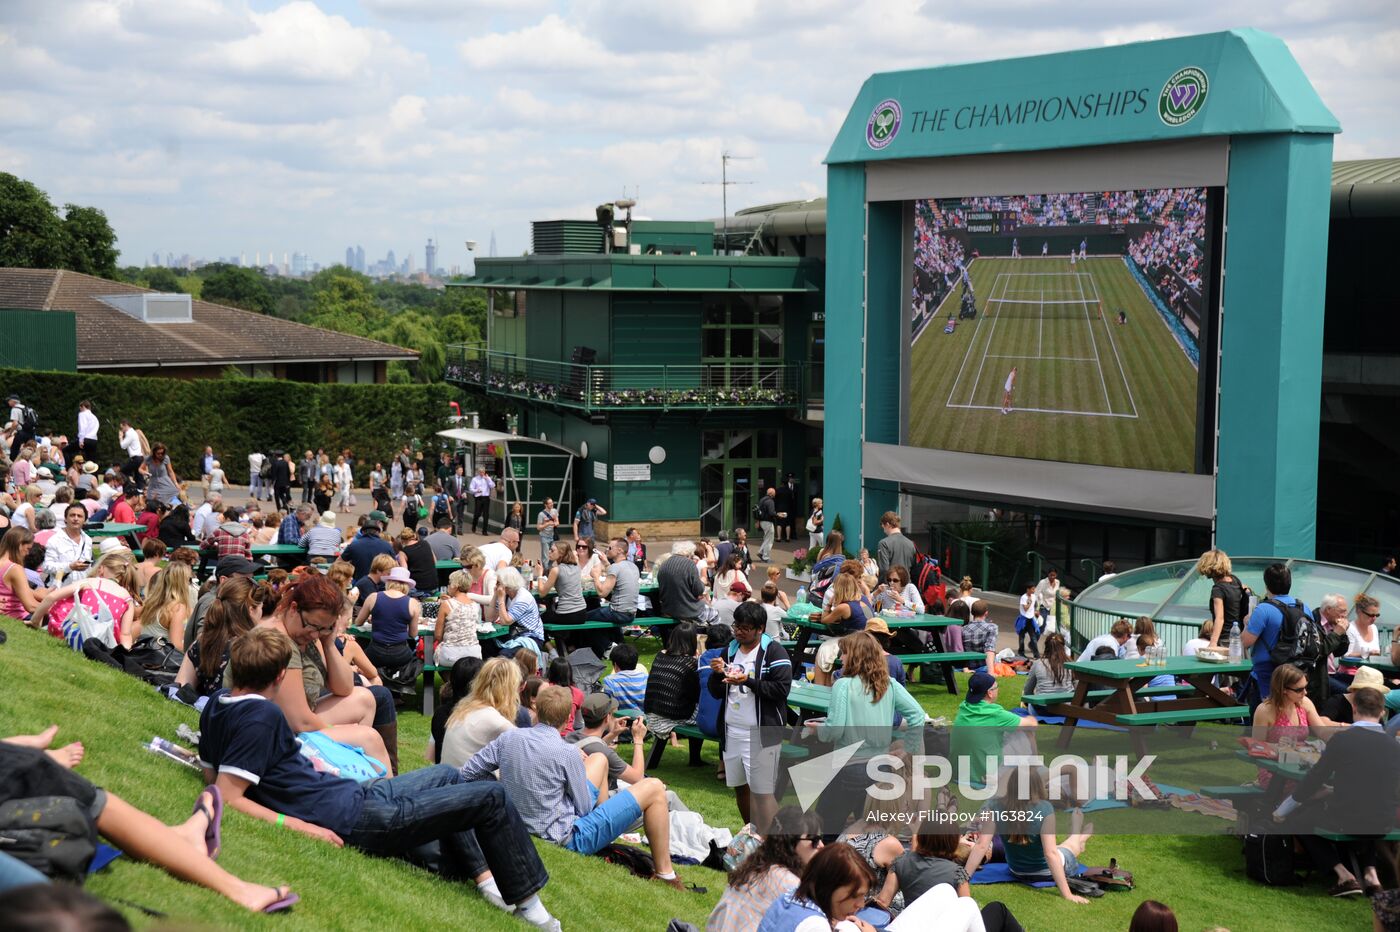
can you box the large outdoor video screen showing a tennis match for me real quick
[906,188,1217,473]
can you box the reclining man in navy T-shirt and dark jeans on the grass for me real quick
[199,627,567,931]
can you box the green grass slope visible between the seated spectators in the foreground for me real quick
[0,619,1371,932]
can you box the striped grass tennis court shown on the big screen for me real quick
[909,257,1196,472]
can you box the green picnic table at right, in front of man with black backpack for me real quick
[1046,656,1253,756]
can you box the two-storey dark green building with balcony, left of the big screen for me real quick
[448,215,825,539]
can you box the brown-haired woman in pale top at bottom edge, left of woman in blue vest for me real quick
[704,806,822,932]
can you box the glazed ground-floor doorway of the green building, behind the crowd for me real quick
[700,427,783,536]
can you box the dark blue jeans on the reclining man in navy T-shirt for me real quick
[346,765,549,903]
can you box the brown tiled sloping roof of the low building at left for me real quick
[0,269,419,369]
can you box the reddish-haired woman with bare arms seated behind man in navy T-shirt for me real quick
[262,572,399,771]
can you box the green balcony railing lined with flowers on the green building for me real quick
[447,344,805,411]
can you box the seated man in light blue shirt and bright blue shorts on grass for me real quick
[462,686,686,890]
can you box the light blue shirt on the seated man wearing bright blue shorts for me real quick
[462,725,594,845]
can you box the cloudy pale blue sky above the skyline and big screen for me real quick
[0,0,1400,266]
